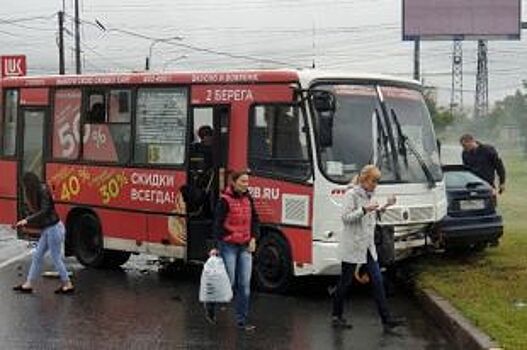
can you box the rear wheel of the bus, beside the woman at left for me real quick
[73,213,104,268]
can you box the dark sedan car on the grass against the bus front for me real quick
[434,165,503,251]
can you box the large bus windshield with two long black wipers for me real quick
[314,83,442,183]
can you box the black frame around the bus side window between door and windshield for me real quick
[246,98,314,184]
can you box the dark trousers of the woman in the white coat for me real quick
[333,251,390,323]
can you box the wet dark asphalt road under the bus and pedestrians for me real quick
[0,226,453,350]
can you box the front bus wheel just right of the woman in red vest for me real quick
[254,232,293,293]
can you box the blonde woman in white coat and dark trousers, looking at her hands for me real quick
[331,165,404,330]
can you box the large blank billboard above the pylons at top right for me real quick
[403,0,521,40]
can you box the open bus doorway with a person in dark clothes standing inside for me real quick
[184,106,230,260]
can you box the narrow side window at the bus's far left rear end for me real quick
[1,90,18,156]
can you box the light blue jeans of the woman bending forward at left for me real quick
[27,222,70,283]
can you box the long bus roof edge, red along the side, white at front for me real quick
[0,69,420,88]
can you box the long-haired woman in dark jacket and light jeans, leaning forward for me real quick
[13,173,74,294]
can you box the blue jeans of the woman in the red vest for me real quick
[205,242,253,326]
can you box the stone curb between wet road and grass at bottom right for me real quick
[415,289,502,350]
